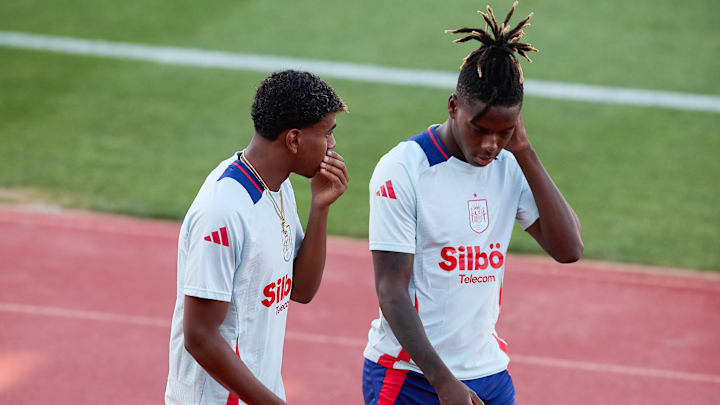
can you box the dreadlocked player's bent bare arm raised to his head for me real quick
[505,113,584,263]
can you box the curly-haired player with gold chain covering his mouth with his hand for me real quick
[165,70,348,405]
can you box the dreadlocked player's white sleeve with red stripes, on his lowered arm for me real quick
[369,156,417,254]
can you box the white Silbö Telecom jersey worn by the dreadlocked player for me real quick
[364,126,538,380]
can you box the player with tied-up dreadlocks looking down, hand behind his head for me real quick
[363,2,583,405]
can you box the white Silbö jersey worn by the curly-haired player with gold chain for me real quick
[165,153,303,405]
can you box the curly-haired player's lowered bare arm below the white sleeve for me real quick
[183,295,285,405]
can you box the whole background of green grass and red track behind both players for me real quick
[0,0,720,405]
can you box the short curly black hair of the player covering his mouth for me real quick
[251,70,347,141]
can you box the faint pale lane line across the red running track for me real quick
[0,302,720,384]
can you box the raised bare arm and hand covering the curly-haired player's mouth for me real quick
[290,150,349,304]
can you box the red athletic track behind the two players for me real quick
[0,207,720,405]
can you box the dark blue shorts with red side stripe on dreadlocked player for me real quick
[363,359,515,405]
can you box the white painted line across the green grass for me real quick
[0,31,720,112]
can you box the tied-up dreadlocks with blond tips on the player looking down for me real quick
[445,1,539,115]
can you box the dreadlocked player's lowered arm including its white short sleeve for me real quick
[369,150,482,405]
